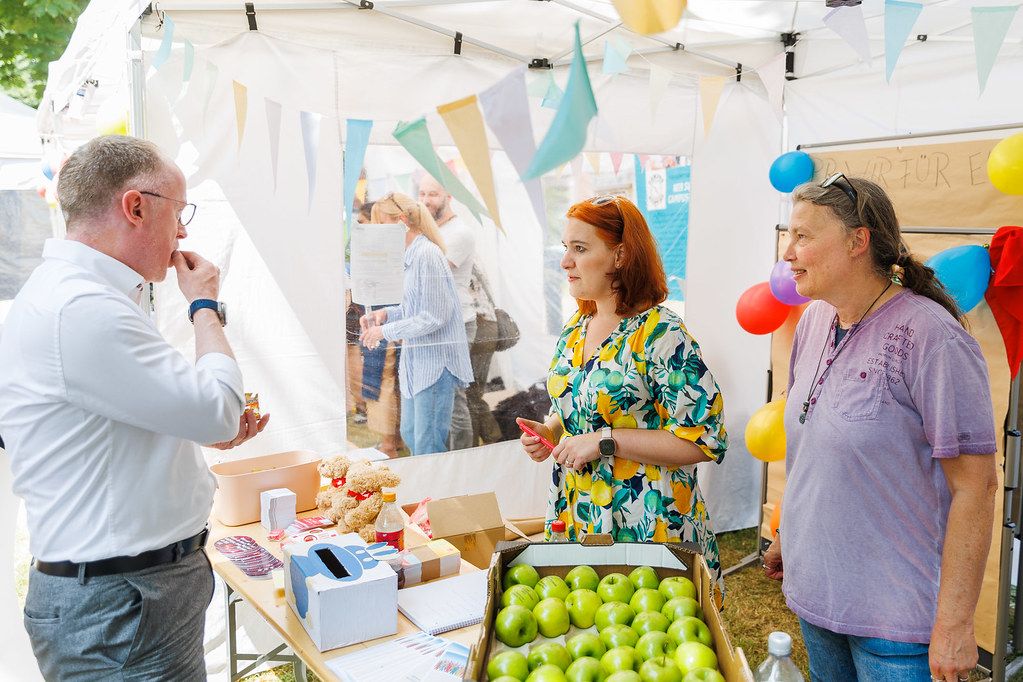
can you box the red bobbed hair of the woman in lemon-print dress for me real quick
[565,196,668,315]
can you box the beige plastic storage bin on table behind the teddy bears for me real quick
[210,450,320,526]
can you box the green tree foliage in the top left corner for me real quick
[0,0,89,106]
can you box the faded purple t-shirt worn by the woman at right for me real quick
[780,289,996,643]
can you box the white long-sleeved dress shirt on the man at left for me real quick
[0,239,244,561]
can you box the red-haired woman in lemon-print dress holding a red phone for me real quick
[518,196,727,608]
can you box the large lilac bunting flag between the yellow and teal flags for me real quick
[479,66,547,238]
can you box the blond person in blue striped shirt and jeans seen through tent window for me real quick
[360,193,473,455]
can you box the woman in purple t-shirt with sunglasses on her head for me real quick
[764,174,997,682]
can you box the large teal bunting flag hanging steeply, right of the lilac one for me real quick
[523,21,596,180]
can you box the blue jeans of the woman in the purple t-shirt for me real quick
[799,619,931,682]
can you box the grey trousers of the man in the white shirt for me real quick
[25,550,213,682]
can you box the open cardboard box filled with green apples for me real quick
[465,536,753,682]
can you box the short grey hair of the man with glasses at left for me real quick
[57,135,169,226]
